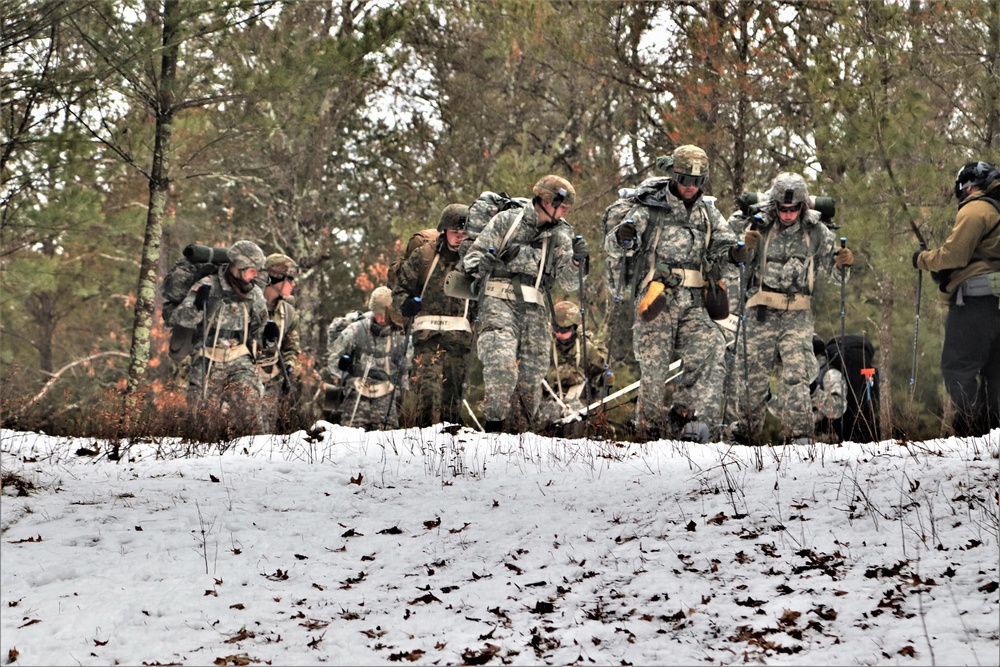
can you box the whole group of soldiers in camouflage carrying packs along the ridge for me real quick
[168,145,995,444]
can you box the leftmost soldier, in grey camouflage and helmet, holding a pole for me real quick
[170,241,267,433]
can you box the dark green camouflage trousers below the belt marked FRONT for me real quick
[403,332,471,427]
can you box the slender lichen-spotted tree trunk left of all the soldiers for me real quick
[123,0,179,410]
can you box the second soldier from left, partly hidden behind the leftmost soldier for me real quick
[257,253,302,430]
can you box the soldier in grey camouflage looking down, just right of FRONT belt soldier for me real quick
[462,175,589,432]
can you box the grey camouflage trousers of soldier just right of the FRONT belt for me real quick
[476,297,552,430]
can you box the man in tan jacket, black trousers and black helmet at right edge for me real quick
[913,162,1000,436]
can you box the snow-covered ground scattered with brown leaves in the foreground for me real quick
[0,422,1000,665]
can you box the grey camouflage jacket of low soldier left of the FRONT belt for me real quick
[328,311,406,382]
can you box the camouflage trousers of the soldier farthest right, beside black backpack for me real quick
[732,306,819,439]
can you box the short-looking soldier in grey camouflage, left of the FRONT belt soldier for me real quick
[328,287,406,430]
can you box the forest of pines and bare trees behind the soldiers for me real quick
[0,0,1000,439]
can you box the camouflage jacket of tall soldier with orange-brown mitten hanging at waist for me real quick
[604,184,738,296]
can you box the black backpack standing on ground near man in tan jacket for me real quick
[820,334,881,442]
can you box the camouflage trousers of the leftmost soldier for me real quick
[187,356,265,433]
